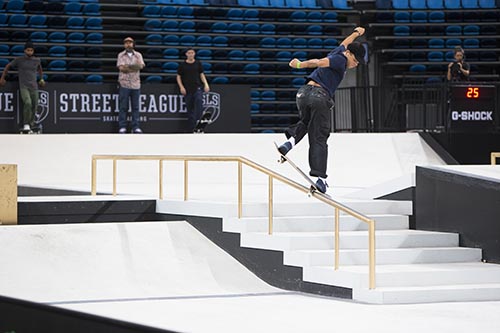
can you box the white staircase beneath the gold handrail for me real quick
[157,199,500,304]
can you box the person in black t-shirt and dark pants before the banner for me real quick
[177,49,210,132]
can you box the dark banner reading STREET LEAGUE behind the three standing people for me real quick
[0,82,250,133]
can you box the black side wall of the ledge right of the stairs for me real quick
[415,167,500,263]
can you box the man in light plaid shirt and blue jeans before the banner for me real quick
[116,37,145,134]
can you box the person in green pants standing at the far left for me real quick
[0,42,45,133]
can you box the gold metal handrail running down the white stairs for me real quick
[91,155,375,289]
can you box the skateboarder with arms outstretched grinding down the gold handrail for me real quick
[278,27,366,193]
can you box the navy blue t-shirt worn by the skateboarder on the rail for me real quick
[307,45,347,98]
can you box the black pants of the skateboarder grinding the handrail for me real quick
[285,85,334,178]
